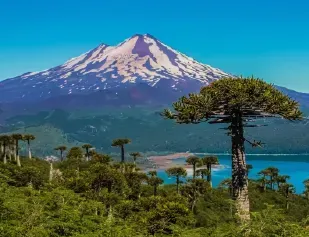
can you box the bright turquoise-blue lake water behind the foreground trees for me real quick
[158,155,309,193]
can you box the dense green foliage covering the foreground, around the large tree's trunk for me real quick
[0,156,309,237]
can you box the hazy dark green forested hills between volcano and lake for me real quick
[2,105,309,156]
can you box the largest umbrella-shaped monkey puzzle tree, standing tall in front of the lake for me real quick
[162,77,302,221]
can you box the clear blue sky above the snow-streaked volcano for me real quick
[0,0,309,92]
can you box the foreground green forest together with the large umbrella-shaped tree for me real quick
[0,78,309,237]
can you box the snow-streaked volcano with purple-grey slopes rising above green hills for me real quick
[0,34,309,110]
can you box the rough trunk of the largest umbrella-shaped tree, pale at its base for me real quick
[231,111,250,221]
